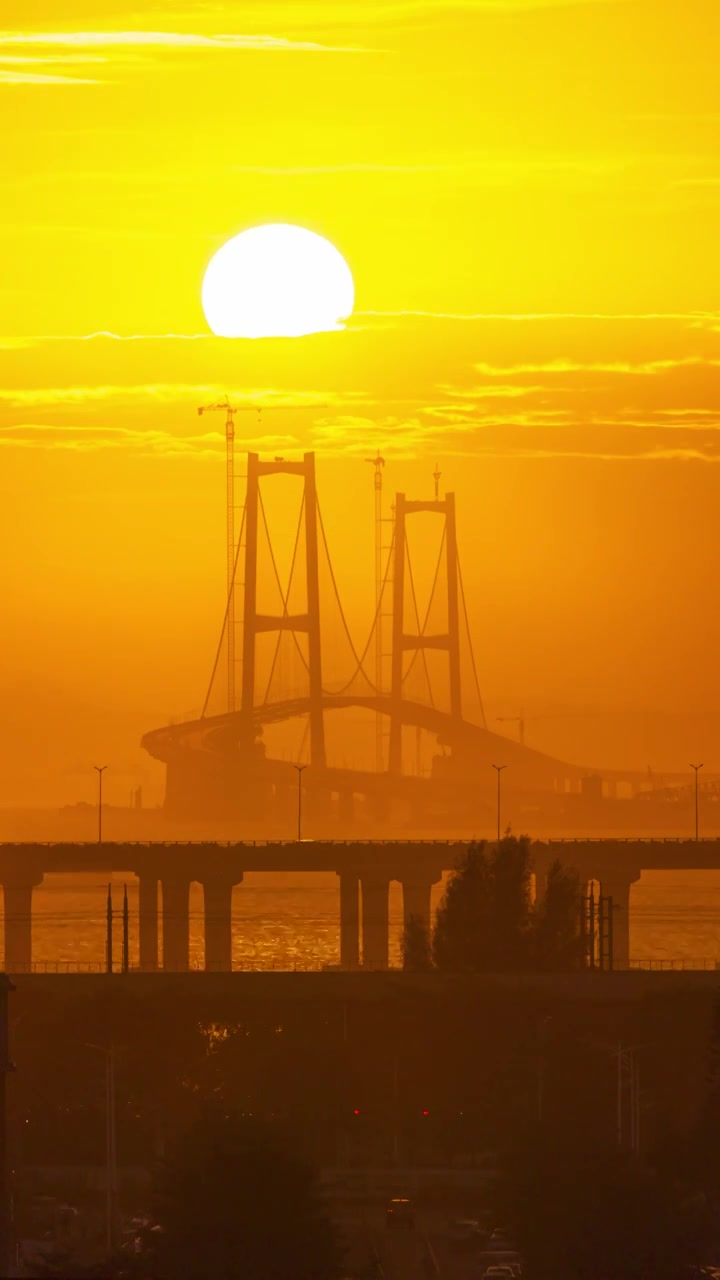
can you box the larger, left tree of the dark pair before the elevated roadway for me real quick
[433,835,532,973]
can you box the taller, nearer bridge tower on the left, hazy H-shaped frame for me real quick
[241,453,325,767]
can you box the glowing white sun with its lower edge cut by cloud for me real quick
[202,223,355,338]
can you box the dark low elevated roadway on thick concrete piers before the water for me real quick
[0,840,720,973]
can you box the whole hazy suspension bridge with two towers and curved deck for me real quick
[142,450,587,833]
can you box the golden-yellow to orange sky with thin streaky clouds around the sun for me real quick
[0,0,720,805]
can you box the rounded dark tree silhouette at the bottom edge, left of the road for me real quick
[156,1108,340,1280]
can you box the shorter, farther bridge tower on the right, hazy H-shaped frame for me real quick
[388,484,462,774]
